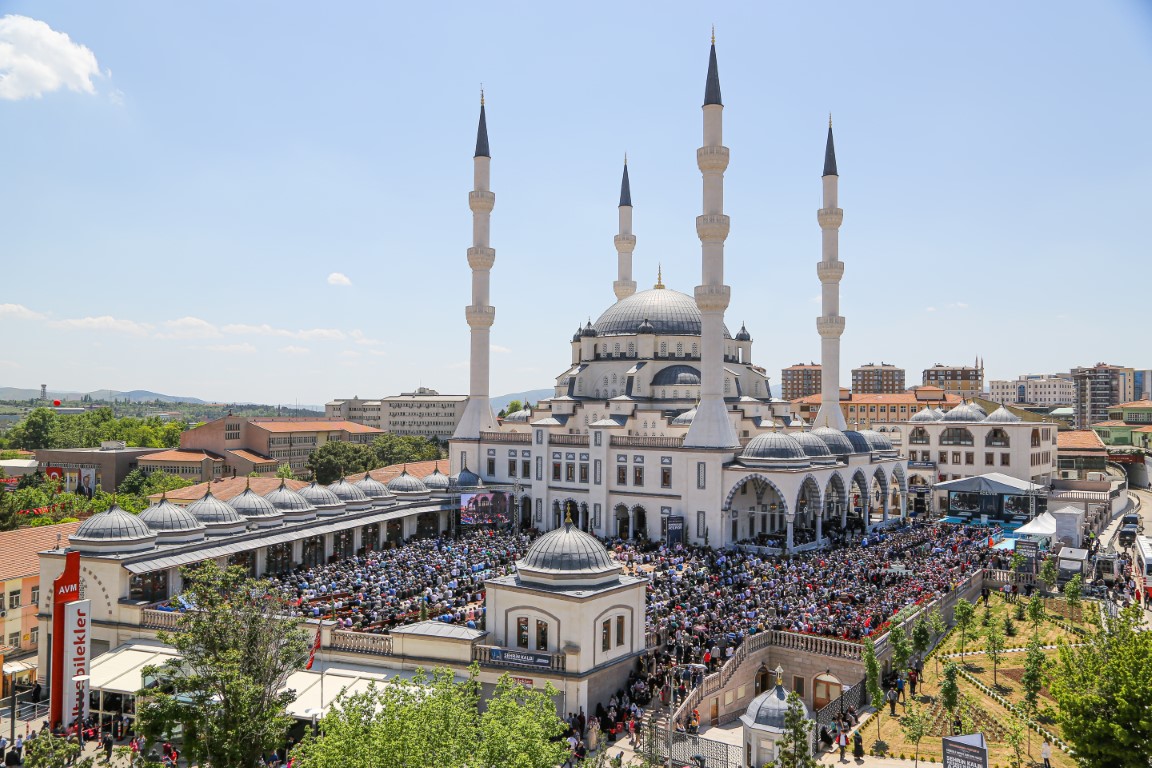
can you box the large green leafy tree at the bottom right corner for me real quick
[1048,606,1152,768]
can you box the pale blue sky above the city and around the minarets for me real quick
[0,0,1152,403]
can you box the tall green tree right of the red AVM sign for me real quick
[137,560,310,768]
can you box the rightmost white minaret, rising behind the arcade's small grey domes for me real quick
[812,115,848,429]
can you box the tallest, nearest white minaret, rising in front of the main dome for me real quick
[684,31,740,448]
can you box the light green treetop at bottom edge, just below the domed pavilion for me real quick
[474,672,568,768]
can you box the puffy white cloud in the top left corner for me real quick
[0,15,100,101]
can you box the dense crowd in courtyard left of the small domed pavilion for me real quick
[268,530,531,633]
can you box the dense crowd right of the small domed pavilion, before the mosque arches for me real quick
[612,523,998,669]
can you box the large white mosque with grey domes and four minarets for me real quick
[450,40,908,550]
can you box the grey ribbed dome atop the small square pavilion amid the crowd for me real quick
[516,518,620,586]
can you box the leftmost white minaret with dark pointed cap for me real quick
[453,91,497,437]
